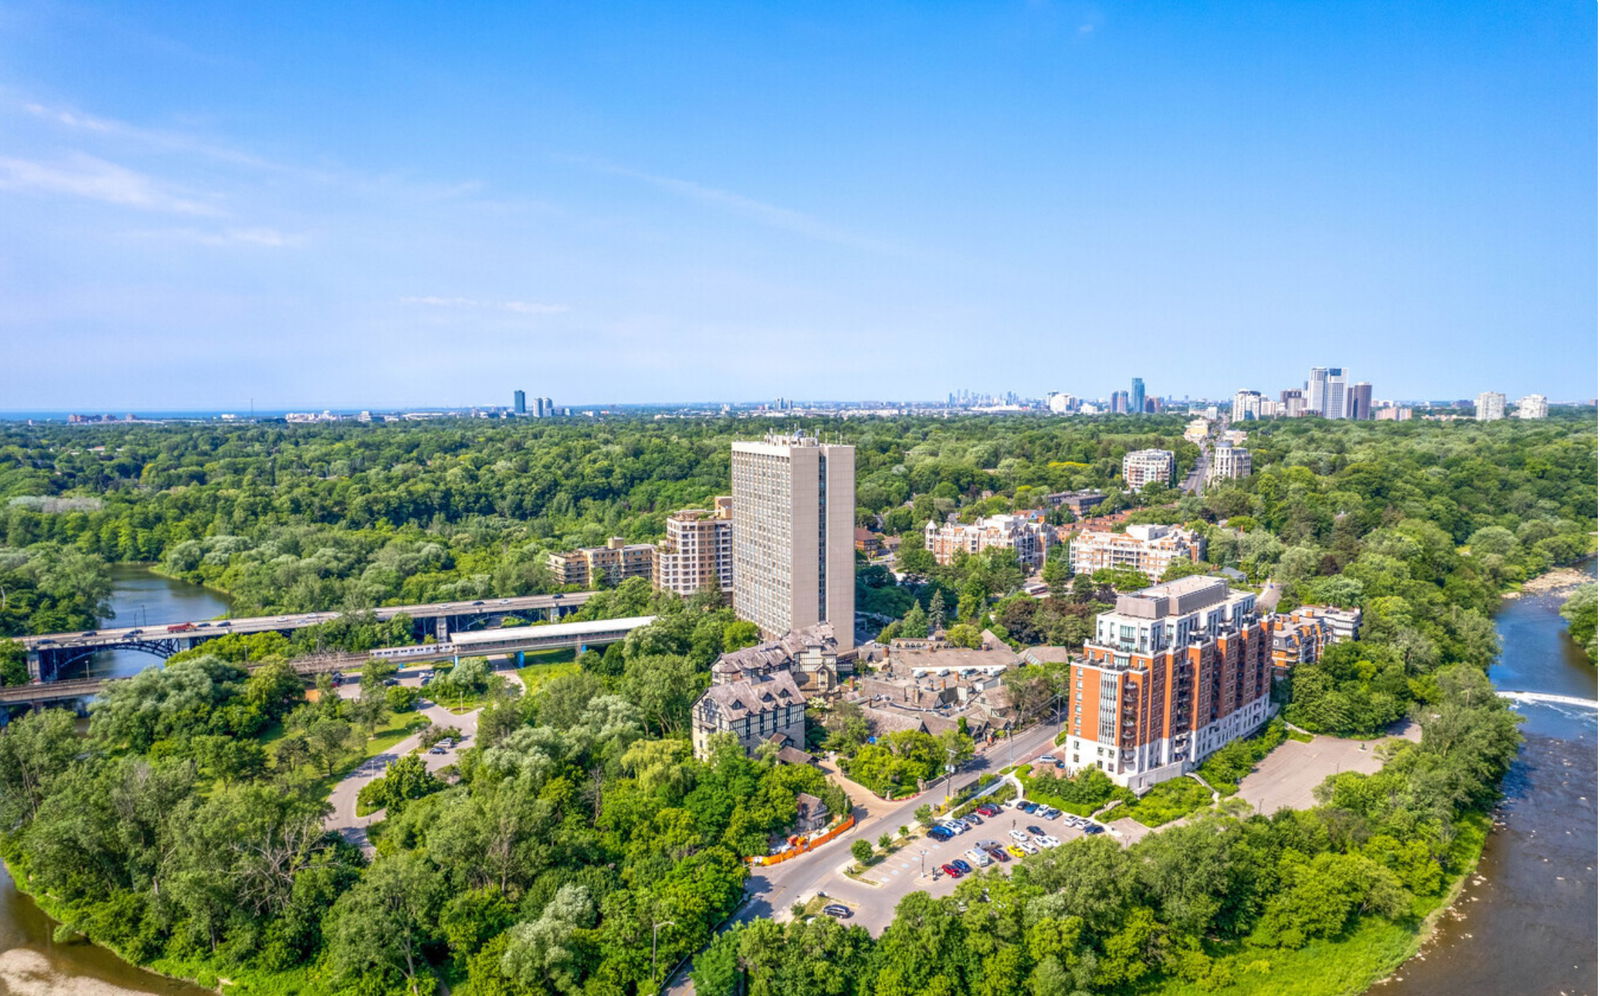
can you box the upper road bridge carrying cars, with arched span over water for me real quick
[21,591,595,682]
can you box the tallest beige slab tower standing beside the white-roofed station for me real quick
[733,432,856,650]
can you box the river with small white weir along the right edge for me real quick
[1373,560,1597,996]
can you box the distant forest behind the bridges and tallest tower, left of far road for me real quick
[0,416,1197,636]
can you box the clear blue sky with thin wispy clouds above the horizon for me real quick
[0,0,1597,410]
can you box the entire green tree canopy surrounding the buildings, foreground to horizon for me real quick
[0,416,1595,996]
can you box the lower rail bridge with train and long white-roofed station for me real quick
[0,615,656,709]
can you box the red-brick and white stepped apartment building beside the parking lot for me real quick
[1062,575,1272,791]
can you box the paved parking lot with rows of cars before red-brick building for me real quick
[806,802,1115,934]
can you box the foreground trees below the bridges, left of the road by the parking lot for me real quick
[0,581,848,996]
